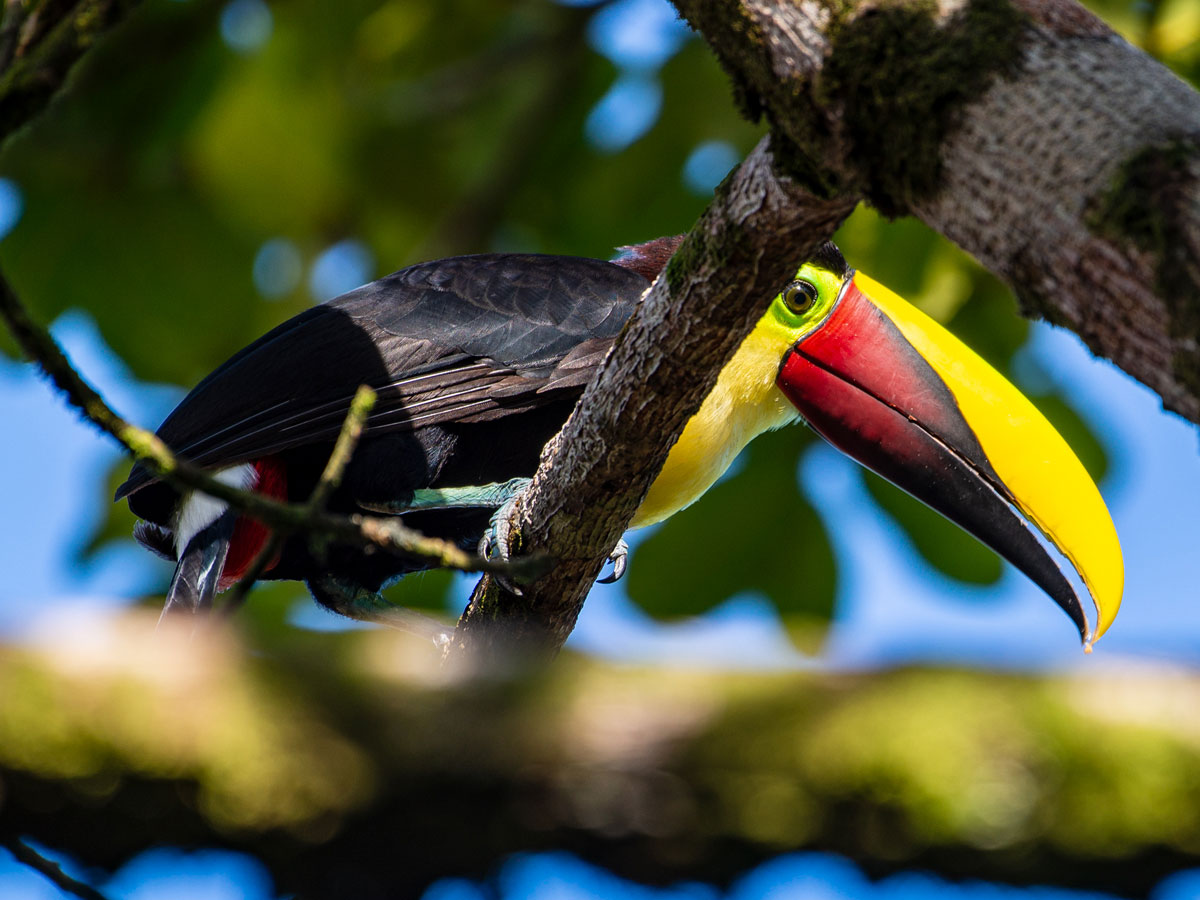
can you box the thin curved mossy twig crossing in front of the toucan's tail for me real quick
[0,272,544,578]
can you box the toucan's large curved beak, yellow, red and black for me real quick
[778,274,1124,648]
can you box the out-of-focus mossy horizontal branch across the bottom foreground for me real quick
[7,613,1200,898]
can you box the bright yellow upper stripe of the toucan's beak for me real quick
[856,274,1124,644]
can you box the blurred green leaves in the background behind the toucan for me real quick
[0,0,1180,634]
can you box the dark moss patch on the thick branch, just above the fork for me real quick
[820,0,1027,216]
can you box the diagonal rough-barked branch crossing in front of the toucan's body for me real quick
[450,139,856,660]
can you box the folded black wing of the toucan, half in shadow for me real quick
[116,253,648,499]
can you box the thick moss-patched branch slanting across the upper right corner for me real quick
[676,0,1200,421]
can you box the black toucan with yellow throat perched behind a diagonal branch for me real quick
[116,238,1123,647]
